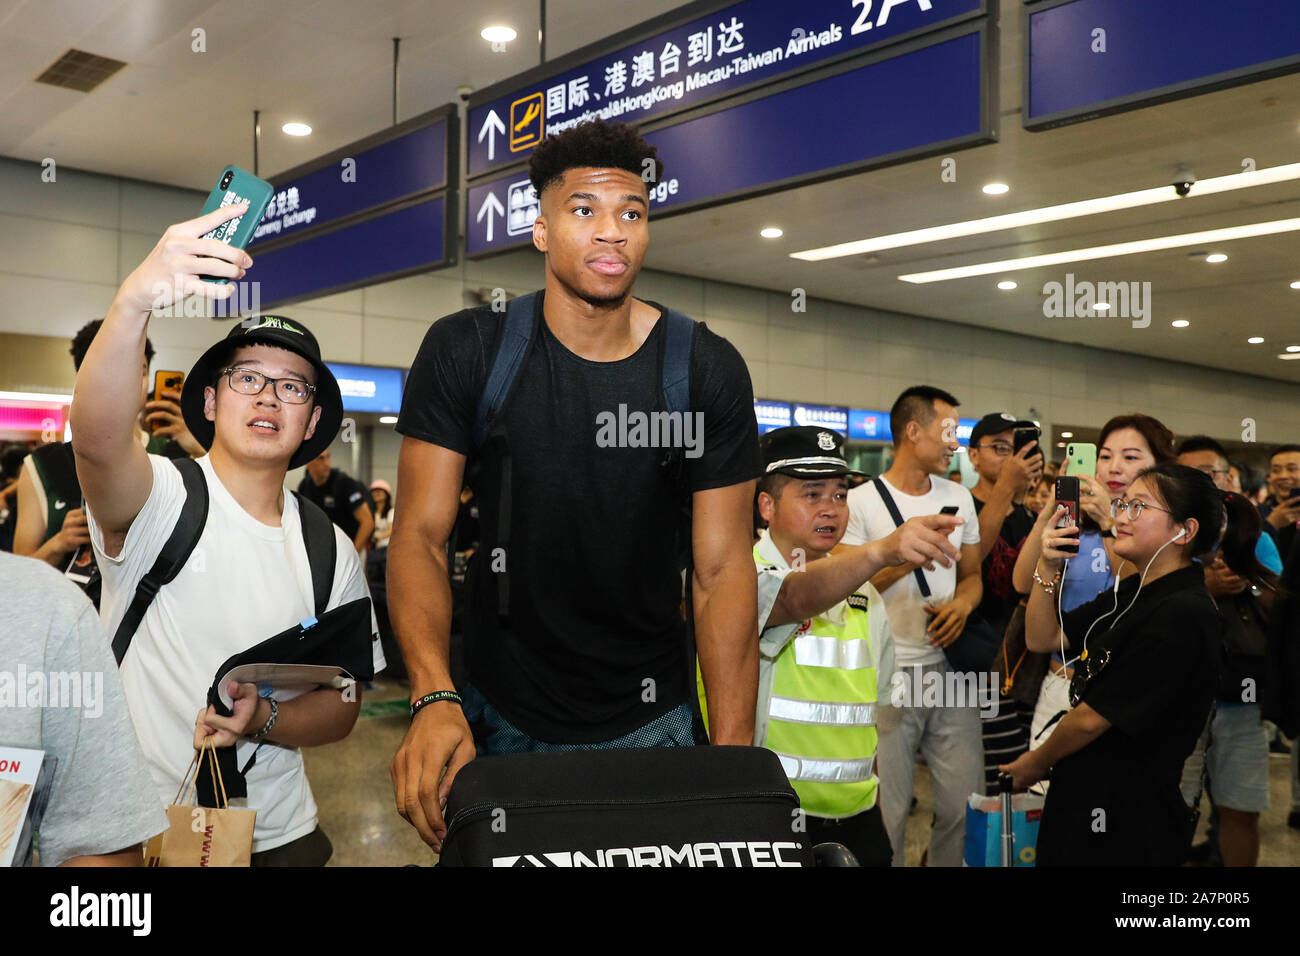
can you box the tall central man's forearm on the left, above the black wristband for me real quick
[387,532,452,697]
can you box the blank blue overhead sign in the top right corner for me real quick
[1023,0,1300,129]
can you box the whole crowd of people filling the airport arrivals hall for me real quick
[0,121,1300,866]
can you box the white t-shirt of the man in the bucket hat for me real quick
[87,455,385,853]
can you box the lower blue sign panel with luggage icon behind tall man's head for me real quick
[465,22,995,256]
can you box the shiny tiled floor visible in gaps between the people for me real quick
[306,680,1300,866]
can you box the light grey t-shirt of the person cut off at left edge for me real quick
[0,553,166,866]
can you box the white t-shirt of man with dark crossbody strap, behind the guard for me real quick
[844,475,979,667]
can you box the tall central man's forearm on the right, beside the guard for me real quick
[696,561,758,747]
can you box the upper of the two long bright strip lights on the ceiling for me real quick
[790,163,1300,261]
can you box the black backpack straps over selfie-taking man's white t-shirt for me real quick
[113,458,338,666]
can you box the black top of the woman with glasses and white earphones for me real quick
[1037,563,1222,866]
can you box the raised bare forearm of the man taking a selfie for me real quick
[69,300,148,464]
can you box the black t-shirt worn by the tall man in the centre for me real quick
[398,295,761,744]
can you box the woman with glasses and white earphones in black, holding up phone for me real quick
[1005,464,1270,866]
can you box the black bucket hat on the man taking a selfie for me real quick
[181,315,343,468]
